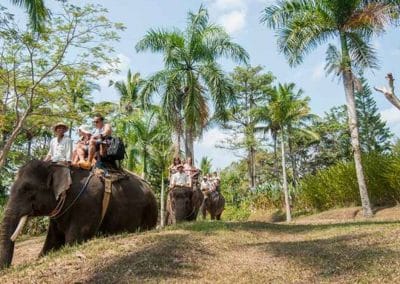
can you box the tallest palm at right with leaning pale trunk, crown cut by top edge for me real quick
[261,0,400,216]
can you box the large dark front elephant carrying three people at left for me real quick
[0,160,158,268]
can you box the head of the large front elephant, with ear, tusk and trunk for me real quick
[0,160,70,268]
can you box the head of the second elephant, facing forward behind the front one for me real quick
[169,187,194,222]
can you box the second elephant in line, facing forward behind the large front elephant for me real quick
[165,186,204,225]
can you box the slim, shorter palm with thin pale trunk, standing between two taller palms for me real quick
[261,83,310,222]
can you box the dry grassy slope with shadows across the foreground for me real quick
[0,211,400,283]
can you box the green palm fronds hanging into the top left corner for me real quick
[11,0,50,32]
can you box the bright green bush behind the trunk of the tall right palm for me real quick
[295,154,400,210]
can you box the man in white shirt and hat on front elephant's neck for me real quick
[45,122,72,164]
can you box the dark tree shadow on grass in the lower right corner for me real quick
[249,234,400,280]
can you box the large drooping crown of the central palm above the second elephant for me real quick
[136,6,249,158]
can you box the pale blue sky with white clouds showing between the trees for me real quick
[13,0,400,168]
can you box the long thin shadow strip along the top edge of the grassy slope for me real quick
[179,221,400,234]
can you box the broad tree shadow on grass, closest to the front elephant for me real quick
[85,233,212,283]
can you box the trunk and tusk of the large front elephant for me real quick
[0,203,27,269]
